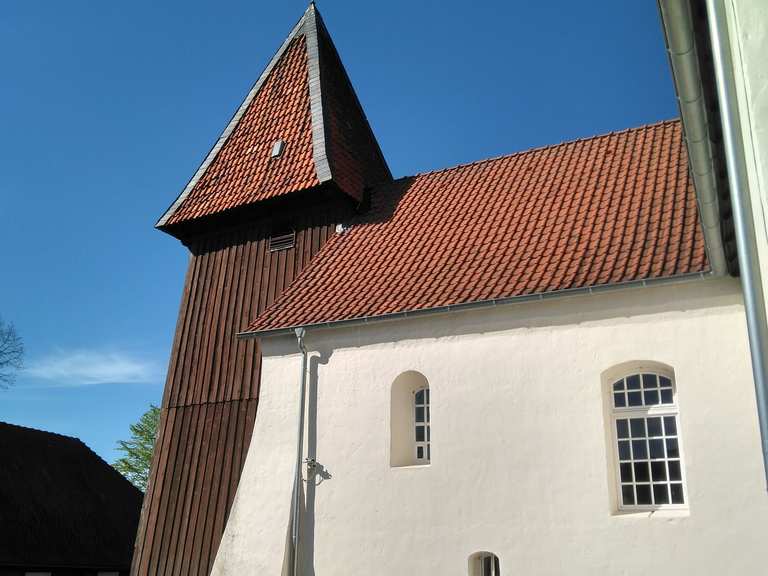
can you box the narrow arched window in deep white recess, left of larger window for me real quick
[389,370,432,467]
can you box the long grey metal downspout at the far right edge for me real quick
[707,0,768,483]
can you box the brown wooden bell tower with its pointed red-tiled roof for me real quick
[131,4,391,576]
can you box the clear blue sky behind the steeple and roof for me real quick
[0,0,678,461]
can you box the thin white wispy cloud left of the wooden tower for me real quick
[20,350,162,386]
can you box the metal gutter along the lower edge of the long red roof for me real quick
[236,271,719,340]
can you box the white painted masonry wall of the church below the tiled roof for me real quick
[213,279,768,576]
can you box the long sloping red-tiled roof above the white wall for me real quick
[248,120,708,332]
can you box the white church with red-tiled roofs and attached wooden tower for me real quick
[132,4,768,576]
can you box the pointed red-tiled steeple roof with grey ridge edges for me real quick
[157,3,392,230]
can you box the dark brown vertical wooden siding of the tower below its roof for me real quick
[131,205,338,576]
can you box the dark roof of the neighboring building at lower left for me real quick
[0,422,142,570]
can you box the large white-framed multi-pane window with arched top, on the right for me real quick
[611,372,686,509]
